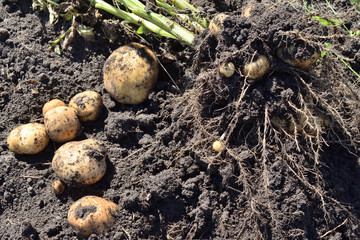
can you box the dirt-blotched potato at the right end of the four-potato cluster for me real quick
[69,91,103,122]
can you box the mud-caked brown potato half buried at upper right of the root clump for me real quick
[276,43,320,69]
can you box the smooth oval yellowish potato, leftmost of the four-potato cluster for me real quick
[7,123,49,154]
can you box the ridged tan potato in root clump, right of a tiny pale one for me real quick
[243,55,270,80]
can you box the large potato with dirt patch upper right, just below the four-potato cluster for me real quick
[52,139,106,186]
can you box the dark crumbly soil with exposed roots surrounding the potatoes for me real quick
[0,0,360,240]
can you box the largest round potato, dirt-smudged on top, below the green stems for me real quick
[103,43,159,104]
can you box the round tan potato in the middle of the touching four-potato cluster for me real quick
[44,106,82,143]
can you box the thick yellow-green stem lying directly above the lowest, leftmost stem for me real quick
[117,0,195,44]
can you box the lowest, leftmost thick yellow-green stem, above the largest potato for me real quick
[89,0,178,39]
